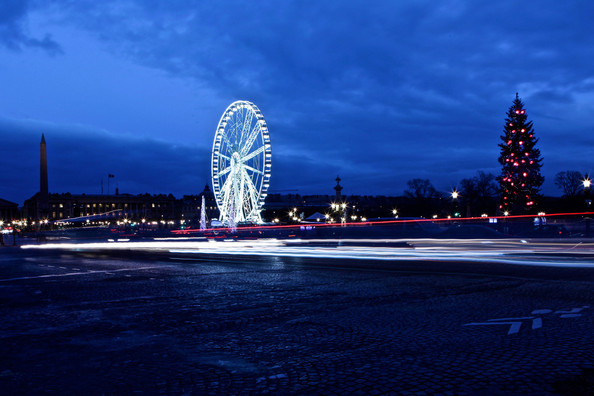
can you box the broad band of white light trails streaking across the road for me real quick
[22,239,594,268]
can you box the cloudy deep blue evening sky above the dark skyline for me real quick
[0,0,594,204]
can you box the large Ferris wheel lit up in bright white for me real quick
[211,100,271,225]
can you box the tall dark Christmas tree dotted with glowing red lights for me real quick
[497,93,544,214]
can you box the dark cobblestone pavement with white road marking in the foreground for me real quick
[0,248,594,395]
